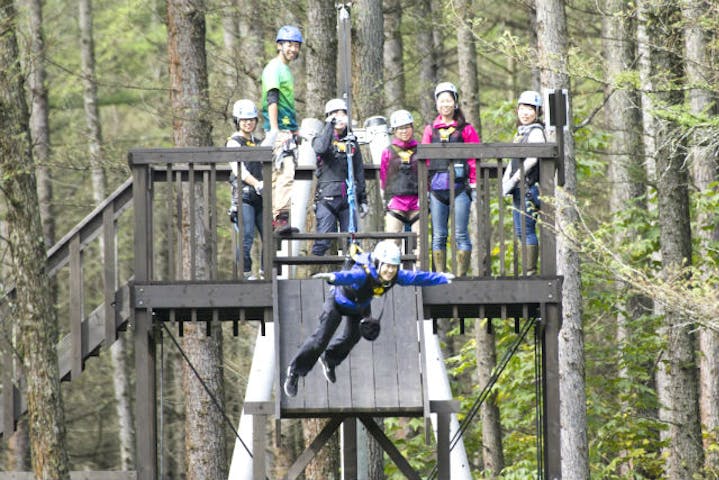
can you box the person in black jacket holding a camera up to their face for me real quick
[312,98,369,255]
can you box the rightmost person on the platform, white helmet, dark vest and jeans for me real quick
[502,90,547,275]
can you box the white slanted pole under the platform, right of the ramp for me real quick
[423,320,472,480]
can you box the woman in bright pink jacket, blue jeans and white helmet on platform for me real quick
[422,82,479,277]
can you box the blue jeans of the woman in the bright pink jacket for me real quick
[429,190,472,251]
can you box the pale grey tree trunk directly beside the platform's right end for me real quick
[536,0,589,480]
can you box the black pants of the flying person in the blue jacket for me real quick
[290,295,366,377]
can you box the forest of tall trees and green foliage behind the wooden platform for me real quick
[0,0,719,480]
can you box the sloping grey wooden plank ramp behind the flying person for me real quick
[274,280,429,418]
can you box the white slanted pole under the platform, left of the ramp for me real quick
[227,322,275,480]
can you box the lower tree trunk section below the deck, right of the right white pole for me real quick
[475,319,504,478]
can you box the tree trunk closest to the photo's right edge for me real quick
[682,0,719,472]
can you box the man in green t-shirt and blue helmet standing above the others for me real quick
[262,25,302,234]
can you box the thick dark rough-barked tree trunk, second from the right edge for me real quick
[646,2,704,478]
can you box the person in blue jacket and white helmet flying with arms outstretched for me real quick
[284,240,454,397]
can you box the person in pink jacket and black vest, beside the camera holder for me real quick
[379,110,420,268]
